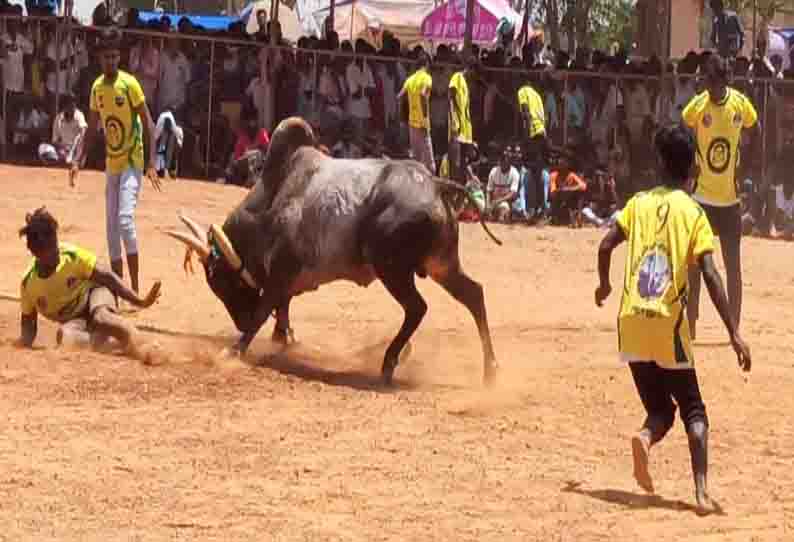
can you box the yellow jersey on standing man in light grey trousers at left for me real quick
[91,70,146,175]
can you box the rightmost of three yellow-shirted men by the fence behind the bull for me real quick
[518,79,548,221]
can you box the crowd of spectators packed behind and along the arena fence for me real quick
[0,2,794,237]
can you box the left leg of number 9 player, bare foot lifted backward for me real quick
[629,362,675,493]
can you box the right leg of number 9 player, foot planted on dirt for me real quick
[664,369,713,514]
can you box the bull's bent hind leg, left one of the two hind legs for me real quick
[379,264,427,386]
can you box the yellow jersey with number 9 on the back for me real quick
[617,186,714,369]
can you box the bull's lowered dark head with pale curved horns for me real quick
[165,214,260,332]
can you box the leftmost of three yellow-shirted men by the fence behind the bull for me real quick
[397,51,436,174]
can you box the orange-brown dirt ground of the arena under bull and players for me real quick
[0,167,794,542]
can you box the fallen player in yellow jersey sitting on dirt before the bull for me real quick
[19,207,160,357]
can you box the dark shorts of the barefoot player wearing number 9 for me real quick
[629,362,708,436]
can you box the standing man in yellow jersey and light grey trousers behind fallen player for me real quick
[69,28,160,302]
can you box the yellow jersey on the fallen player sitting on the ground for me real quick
[20,243,96,323]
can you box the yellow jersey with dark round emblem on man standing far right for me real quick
[681,87,758,207]
